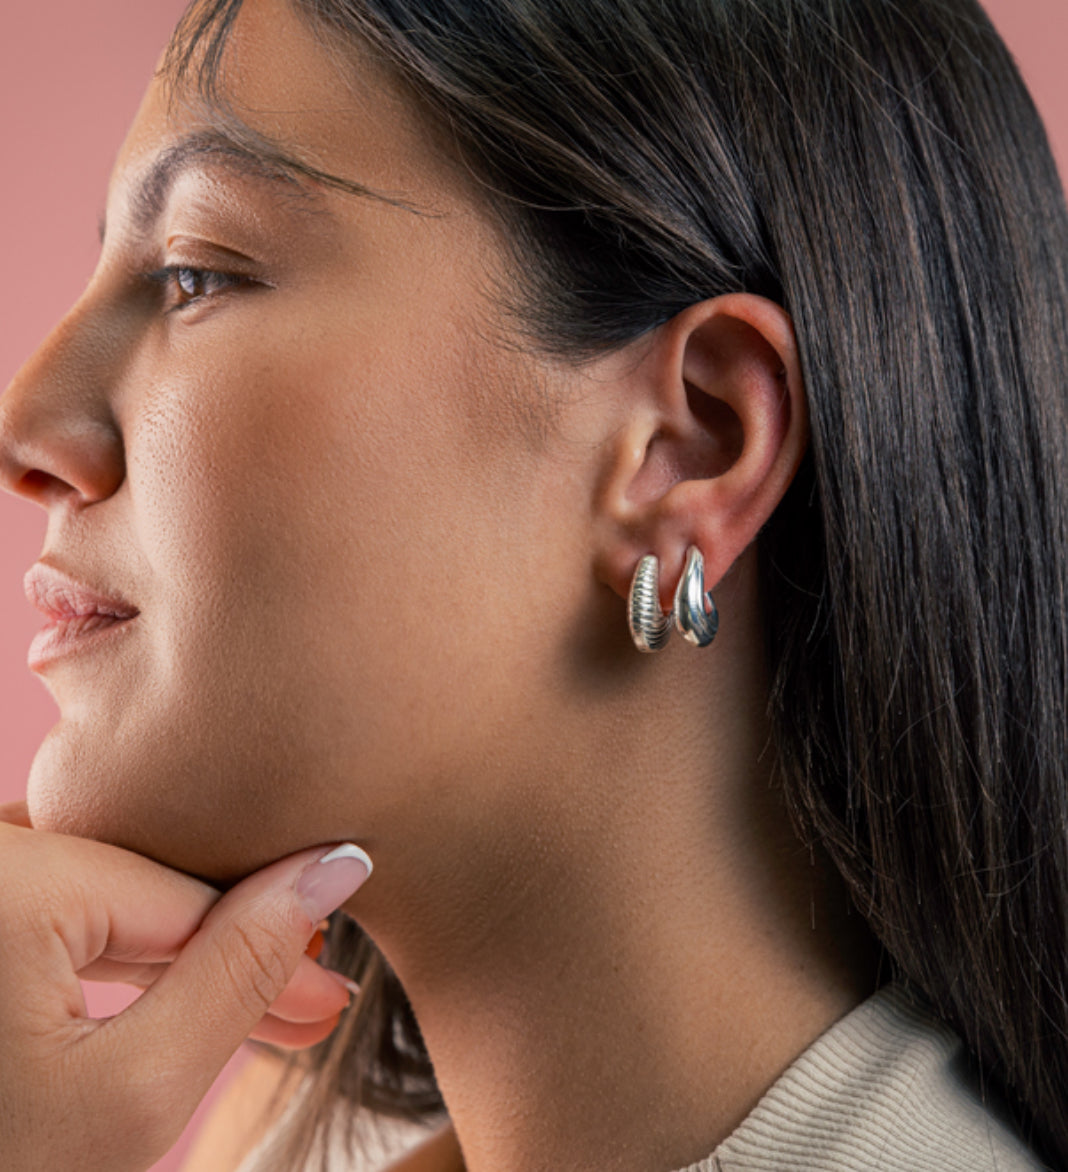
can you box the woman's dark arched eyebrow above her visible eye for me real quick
[100,125,426,244]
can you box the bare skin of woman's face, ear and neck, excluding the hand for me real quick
[0,0,873,1172]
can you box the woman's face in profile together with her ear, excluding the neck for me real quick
[0,0,807,922]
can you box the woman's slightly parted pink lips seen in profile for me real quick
[23,563,140,672]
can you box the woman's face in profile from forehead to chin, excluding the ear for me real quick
[0,0,600,881]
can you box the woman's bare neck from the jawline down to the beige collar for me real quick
[349,564,875,1172]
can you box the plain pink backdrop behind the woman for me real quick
[0,0,1068,1172]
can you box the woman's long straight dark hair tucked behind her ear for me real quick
[166,0,1068,1164]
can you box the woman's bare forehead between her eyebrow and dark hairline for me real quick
[113,0,474,229]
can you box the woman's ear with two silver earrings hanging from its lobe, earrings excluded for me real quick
[596,293,808,611]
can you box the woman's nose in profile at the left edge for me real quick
[0,302,125,509]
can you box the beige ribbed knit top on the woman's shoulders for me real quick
[239,984,1043,1172]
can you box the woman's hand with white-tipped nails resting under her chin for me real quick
[0,803,367,1172]
